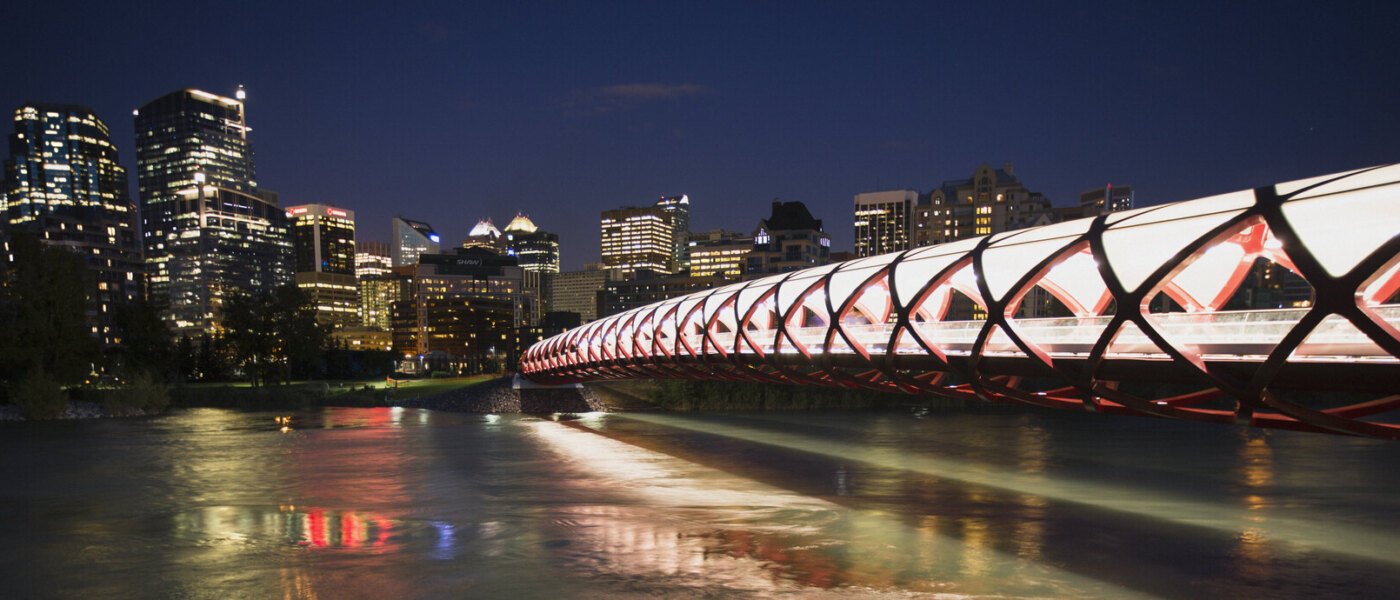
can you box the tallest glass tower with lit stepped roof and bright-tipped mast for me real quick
[136,87,293,336]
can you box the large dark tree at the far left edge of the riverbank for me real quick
[0,232,101,383]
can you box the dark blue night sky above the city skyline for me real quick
[0,1,1400,269]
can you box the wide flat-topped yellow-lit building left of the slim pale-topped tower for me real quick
[602,206,675,278]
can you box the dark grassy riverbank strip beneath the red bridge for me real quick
[591,379,972,411]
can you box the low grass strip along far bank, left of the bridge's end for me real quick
[171,375,500,410]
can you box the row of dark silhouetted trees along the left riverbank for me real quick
[0,232,393,405]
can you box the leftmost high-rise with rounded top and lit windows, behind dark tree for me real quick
[0,102,146,344]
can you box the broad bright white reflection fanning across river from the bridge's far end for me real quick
[531,422,1134,597]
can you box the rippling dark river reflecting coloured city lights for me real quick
[0,407,1400,599]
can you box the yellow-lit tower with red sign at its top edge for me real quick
[287,204,360,329]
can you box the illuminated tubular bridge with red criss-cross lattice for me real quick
[522,165,1400,438]
